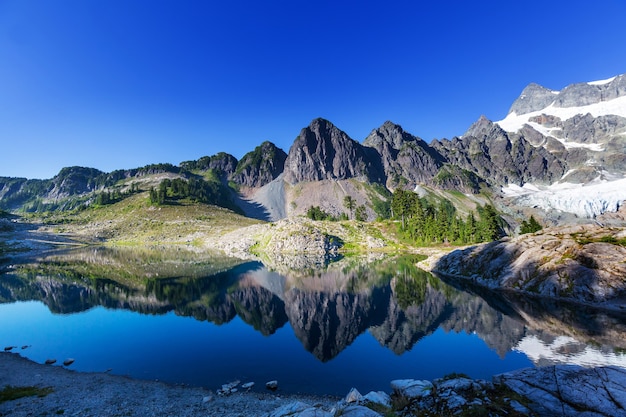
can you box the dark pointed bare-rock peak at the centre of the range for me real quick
[285,118,380,184]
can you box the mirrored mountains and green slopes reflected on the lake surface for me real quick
[0,248,626,394]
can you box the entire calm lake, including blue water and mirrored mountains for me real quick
[0,248,626,395]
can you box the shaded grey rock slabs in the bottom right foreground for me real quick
[271,366,626,417]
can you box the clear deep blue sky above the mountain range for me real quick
[0,0,626,178]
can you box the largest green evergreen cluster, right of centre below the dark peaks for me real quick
[391,189,503,244]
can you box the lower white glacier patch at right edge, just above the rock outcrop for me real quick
[502,178,626,218]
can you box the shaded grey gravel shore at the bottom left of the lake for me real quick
[0,352,338,417]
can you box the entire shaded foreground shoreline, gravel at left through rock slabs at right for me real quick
[0,352,626,417]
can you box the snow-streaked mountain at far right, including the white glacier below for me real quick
[496,74,626,218]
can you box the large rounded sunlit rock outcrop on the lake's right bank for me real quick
[434,225,626,308]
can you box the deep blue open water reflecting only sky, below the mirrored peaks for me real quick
[0,301,532,395]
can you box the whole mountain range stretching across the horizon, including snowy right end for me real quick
[0,75,626,224]
